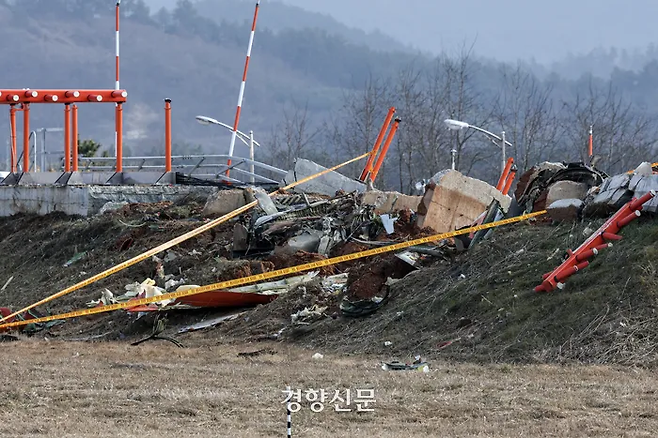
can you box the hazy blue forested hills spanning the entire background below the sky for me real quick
[0,0,658,191]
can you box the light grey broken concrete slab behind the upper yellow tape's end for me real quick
[284,158,366,196]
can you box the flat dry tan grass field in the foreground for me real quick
[0,339,658,438]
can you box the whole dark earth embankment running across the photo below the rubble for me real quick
[0,198,658,366]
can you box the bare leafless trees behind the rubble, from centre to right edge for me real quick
[271,48,658,193]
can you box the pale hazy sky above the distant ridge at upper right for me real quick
[147,0,658,62]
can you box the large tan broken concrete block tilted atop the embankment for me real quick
[416,170,512,233]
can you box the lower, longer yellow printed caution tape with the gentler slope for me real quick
[0,210,546,329]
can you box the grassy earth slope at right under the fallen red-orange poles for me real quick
[219,218,658,365]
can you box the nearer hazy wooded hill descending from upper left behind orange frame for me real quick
[0,3,356,157]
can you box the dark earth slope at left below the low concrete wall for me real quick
[0,198,232,318]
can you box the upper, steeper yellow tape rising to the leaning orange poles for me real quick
[0,152,370,323]
